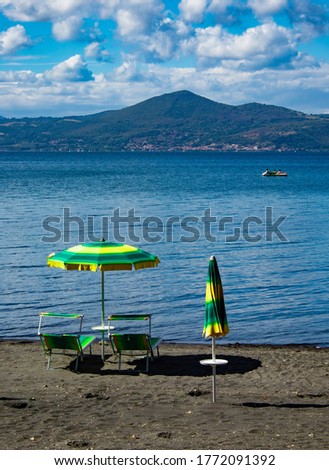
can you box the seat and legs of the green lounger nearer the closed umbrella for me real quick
[110,333,162,372]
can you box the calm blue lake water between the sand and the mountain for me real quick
[0,153,329,346]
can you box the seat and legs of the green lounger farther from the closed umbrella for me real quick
[39,333,96,370]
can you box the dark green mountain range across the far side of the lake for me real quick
[0,91,329,152]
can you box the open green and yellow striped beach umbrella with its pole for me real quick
[47,240,160,360]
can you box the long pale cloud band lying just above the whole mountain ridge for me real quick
[0,57,329,117]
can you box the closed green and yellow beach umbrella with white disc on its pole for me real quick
[202,256,229,402]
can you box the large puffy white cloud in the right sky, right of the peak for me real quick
[184,23,297,68]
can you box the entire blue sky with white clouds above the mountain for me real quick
[0,0,329,117]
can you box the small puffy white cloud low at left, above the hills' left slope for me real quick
[43,54,93,82]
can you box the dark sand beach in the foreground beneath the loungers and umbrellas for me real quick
[0,341,329,450]
